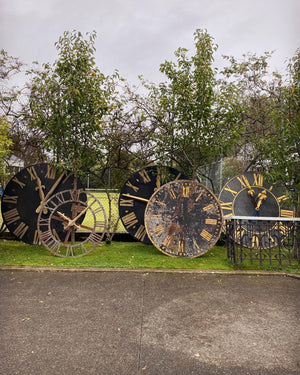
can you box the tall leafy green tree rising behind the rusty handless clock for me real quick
[137,30,241,191]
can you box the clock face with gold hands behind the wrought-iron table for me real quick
[219,172,294,248]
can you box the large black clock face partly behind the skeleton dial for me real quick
[1,163,83,244]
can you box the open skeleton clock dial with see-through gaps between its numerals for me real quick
[38,190,106,257]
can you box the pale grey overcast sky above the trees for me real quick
[0,0,300,82]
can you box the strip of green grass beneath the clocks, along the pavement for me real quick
[0,239,300,273]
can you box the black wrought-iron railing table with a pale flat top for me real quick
[226,216,300,266]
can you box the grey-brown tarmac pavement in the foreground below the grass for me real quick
[0,270,300,375]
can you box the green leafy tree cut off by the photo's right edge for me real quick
[263,49,300,217]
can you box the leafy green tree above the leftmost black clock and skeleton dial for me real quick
[27,31,111,177]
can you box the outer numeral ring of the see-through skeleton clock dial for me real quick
[38,189,107,258]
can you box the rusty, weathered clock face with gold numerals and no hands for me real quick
[145,180,222,258]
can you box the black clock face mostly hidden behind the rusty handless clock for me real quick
[118,165,186,245]
